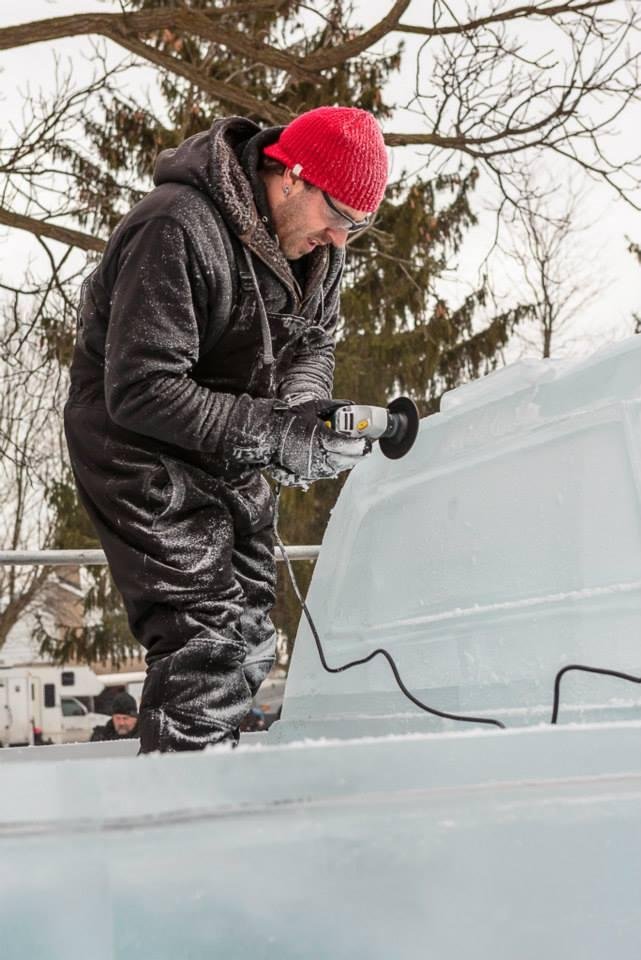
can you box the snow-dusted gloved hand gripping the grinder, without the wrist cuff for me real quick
[270,400,372,488]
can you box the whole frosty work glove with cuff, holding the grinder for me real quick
[222,395,372,489]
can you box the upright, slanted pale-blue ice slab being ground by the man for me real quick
[282,337,641,738]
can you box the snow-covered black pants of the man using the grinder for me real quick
[65,404,276,752]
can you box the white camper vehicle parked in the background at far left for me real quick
[0,664,109,747]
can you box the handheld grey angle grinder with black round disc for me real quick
[325,397,419,460]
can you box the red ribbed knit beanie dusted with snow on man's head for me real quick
[264,107,387,213]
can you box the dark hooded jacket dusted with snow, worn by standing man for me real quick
[70,117,343,468]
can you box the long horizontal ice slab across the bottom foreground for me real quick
[0,723,641,960]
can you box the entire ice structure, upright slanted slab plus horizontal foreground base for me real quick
[0,337,641,960]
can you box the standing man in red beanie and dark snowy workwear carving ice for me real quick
[65,107,387,752]
